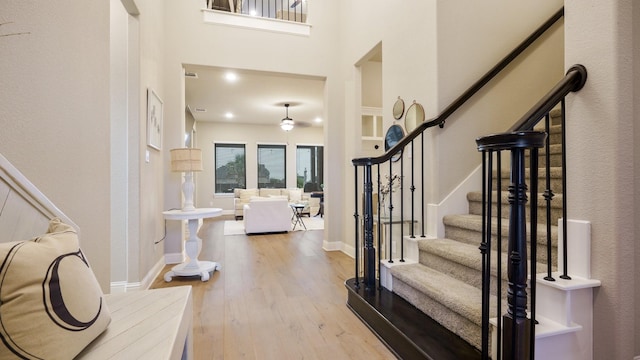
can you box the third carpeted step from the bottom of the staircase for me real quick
[442,214,558,247]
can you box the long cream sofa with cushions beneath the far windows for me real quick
[233,188,320,219]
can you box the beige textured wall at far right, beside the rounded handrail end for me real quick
[565,0,640,359]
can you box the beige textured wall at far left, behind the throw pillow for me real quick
[0,0,110,291]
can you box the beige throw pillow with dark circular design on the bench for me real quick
[0,219,111,360]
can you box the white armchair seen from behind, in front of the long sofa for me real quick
[243,198,293,234]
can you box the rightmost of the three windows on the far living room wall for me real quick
[296,146,324,192]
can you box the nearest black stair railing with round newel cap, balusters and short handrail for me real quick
[476,64,587,360]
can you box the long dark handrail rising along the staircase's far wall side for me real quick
[352,6,564,166]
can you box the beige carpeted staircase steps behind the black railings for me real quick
[390,111,562,348]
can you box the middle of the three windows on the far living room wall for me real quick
[258,145,287,189]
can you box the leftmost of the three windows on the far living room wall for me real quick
[214,144,247,193]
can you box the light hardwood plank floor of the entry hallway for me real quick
[151,217,395,360]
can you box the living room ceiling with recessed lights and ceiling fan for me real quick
[184,65,325,127]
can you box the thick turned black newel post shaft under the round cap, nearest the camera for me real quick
[502,148,535,360]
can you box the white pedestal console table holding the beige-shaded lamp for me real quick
[162,208,222,282]
